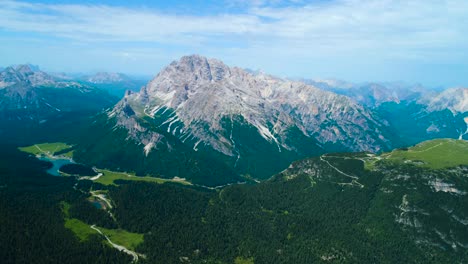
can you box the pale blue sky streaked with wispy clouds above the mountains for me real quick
[0,0,468,87]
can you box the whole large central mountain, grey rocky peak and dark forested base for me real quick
[71,55,390,184]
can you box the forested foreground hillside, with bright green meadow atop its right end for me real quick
[0,139,468,264]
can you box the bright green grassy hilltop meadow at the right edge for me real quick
[382,139,468,169]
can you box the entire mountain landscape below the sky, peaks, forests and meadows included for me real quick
[0,55,468,263]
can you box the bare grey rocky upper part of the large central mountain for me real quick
[111,55,389,156]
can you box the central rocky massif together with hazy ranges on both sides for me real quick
[0,55,468,184]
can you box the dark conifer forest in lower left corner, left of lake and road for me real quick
[0,145,131,263]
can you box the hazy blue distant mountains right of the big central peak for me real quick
[304,79,468,142]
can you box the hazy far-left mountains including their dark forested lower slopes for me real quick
[0,65,118,144]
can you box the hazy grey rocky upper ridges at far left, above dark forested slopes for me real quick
[0,65,115,120]
